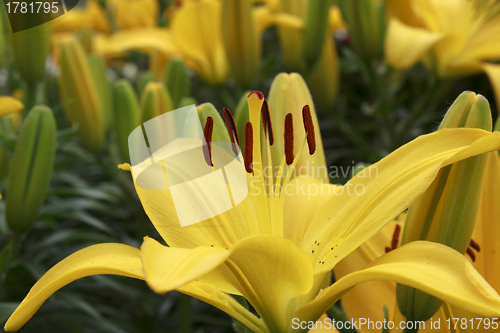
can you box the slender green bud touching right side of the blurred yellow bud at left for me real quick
[88,54,113,130]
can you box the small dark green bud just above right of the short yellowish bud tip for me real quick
[163,58,191,108]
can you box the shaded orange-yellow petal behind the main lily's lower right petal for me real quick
[334,221,400,333]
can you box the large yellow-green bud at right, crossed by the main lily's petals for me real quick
[397,91,492,321]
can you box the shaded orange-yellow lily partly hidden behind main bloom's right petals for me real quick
[334,152,500,333]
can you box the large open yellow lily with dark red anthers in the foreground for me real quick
[5,92,500,333]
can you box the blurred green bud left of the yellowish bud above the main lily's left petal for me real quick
[113,80,141,161]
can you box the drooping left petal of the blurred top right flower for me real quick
[384,19,443,69]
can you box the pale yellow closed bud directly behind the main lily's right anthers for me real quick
[268,73,330,183]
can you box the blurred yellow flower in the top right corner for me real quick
[385,0,500,109]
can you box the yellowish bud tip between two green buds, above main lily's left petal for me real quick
[141,82,174,123]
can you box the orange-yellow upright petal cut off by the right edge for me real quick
[472,152,500,292]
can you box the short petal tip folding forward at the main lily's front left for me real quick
[141,237,229,294]
